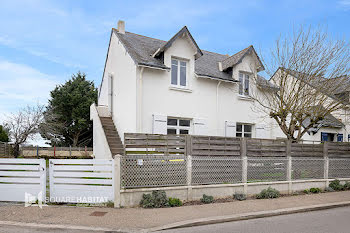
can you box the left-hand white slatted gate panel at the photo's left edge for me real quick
[0,159,46,202]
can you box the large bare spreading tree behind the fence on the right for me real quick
[252,27,350,141]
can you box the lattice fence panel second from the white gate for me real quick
[192,156,242,185]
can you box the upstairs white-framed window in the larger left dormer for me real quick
[171,59,187,87]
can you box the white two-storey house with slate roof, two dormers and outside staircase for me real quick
[91,21,350,158]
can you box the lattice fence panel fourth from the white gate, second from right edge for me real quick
[292,158,324,180]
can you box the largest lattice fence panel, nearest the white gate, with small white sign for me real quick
[122,155,187,188]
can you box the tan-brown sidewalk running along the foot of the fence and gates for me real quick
[0,191,350,231]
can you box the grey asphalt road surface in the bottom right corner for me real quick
[162,207,350,233]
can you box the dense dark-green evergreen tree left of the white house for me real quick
[40,72,97,146]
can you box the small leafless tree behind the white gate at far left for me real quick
[5,105,44,158]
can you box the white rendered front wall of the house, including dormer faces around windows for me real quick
[142,38,271,137]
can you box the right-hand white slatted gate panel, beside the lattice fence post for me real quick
[49,159,114,203]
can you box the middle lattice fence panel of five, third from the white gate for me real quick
[247,158,288,182]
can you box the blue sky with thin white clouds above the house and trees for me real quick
[0,0,350,143]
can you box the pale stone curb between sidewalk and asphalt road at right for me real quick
[147,201,350,232]
